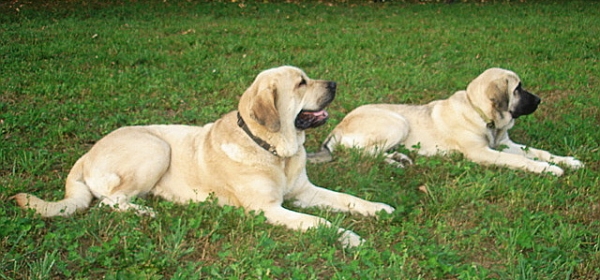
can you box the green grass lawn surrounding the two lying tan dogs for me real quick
[0,0,600,279]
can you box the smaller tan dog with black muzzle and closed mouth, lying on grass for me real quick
[309,68,583,176]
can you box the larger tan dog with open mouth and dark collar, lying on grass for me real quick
[14,66,394,246]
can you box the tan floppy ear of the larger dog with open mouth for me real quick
[239,82,281,132]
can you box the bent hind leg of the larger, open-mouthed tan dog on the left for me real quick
[85,128,171,216]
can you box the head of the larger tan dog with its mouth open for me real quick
[238,66,336,154]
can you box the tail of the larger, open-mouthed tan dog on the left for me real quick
[11,156,92,217]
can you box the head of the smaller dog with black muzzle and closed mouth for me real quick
[467,68,541,123]
